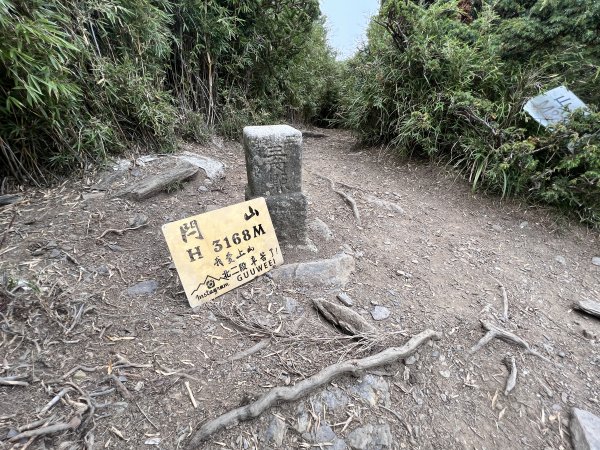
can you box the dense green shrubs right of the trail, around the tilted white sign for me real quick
[339,0,600,224]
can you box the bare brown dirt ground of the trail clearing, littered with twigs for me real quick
[0,127,600,450]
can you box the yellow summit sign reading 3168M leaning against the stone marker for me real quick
[162,197,283,308]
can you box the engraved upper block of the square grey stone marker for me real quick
[244,125,302,196]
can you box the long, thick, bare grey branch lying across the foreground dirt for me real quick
[186,330,441,450]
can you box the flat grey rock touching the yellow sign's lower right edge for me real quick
[270,253,354,287]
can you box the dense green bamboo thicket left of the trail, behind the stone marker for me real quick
[0,0,333,181]
